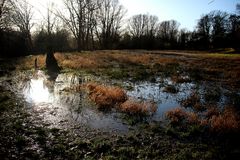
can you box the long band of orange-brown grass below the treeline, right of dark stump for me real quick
[55,51,176,69]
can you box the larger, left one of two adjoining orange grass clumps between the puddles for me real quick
[86,83,127,108]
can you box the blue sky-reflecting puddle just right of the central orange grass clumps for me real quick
[126,79,195,121]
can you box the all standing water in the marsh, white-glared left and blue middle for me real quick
[14,71,239,132]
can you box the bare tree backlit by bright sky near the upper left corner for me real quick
[11,0,33,51]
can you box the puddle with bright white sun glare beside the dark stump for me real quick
[20,71,128,132]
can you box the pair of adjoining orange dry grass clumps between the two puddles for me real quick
[77,83,157,115]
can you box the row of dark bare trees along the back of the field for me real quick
[0,0,240,56]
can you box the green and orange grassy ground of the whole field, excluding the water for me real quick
[0,51,240,159]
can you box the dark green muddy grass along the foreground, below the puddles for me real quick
[0,87,231,159]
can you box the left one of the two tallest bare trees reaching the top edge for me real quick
[59,0,97,51]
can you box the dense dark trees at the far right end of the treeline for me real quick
[195,11,240,49]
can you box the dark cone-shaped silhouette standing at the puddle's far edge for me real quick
[46,50,60,80]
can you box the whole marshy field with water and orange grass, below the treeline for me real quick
[0,50,240,159]
